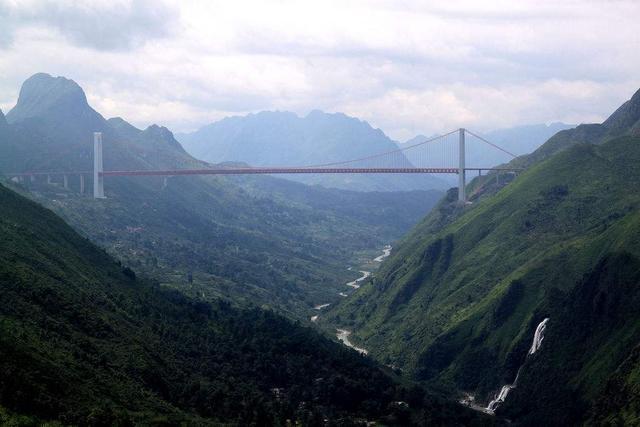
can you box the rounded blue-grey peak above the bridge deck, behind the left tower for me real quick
[0,73,197,171]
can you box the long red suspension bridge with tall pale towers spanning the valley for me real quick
[5,128,521,203]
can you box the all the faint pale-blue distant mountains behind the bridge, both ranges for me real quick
[176,110,574,191]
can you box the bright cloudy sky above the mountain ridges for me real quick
[0,0,640,140]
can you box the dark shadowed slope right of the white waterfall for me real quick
[501,244,640,425]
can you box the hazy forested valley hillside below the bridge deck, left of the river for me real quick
[16,178,438,318]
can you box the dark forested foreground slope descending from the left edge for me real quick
[0,186,484,425]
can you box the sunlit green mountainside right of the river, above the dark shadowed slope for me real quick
[327,137,640,422]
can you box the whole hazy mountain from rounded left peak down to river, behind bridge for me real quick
[0,74,439,318]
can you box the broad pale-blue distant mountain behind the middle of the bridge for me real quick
[177,111,446,191]
